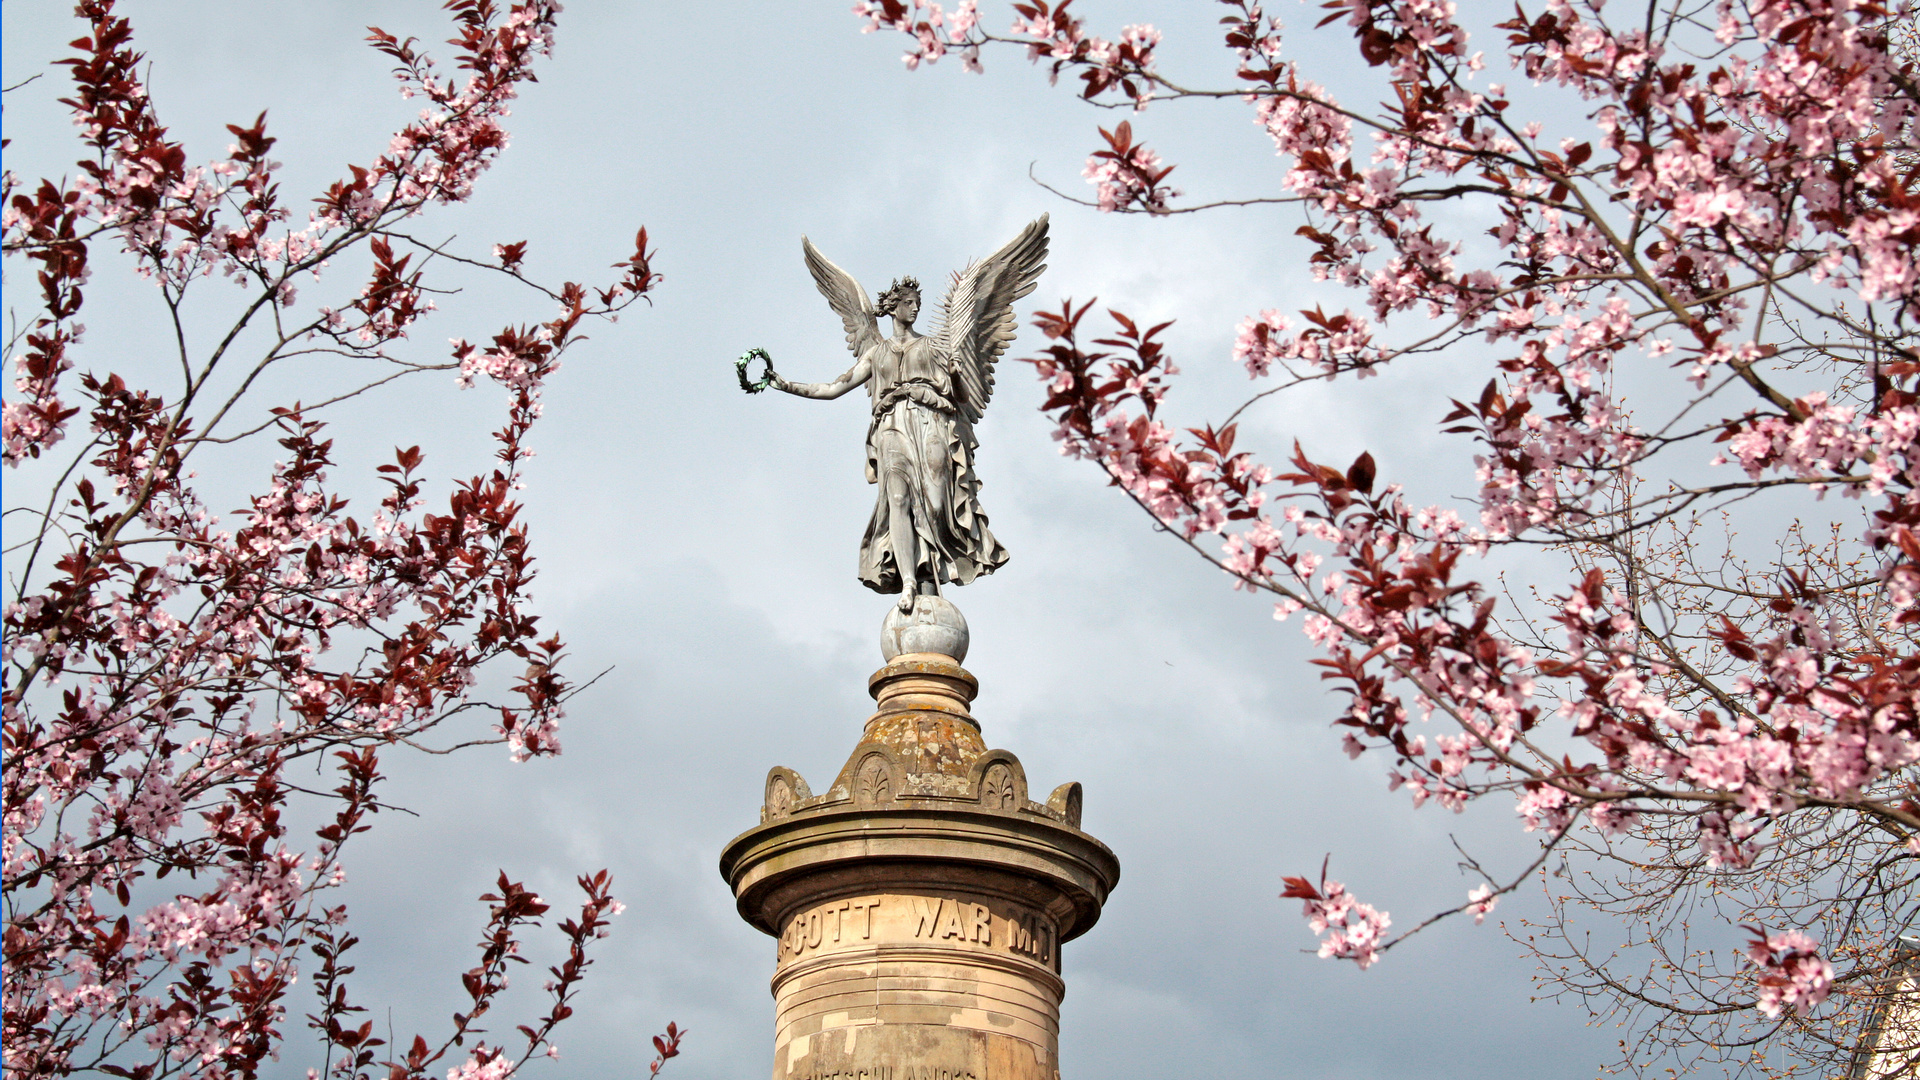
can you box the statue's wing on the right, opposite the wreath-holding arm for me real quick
[939,213,1046,423]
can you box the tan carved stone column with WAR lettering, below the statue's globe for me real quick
[720,653,1119,1080]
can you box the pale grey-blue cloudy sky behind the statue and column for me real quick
[0,0,1617,1080]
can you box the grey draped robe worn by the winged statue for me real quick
[860,338,1006,594]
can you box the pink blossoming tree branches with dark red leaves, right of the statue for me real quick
[854,0,1920,1074]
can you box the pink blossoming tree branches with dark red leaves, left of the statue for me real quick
[0,0,680,1080]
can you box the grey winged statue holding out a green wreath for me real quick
[766,215,1046,613]
